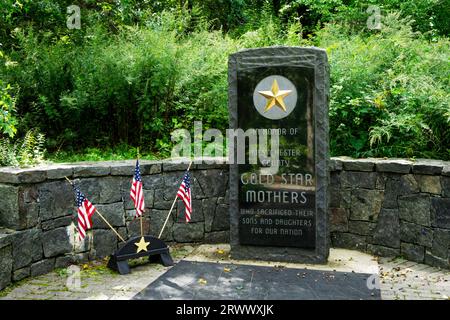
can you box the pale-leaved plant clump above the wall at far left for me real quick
[0,130,45,167]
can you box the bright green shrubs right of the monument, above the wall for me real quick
[317,15,450,159]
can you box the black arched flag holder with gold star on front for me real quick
[108,236,173,275]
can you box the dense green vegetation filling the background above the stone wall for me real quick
[0,0,450,165]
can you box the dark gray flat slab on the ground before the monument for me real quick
[133,260,381,300]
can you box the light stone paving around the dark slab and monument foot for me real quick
[0,245,450,300]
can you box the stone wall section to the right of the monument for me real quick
[330,157,450,268]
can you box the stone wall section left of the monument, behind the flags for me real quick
[0,161,229,290]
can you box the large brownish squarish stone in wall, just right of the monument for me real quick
[350,189,384,222]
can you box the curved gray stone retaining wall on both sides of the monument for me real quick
[0,157,450,290]
